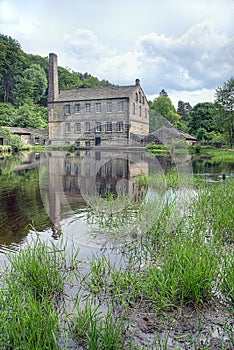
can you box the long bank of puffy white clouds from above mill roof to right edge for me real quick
[61,22,234,100]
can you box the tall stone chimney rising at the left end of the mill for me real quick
[48,53,59,102]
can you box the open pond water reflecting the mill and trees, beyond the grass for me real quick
[0,150,234,259]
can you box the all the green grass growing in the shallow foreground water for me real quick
[0,173,234,350]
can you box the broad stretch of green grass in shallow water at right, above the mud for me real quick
[83,179,234,311]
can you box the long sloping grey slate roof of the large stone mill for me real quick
[57,85,139,101]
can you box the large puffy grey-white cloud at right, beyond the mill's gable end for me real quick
[137,22,234,92]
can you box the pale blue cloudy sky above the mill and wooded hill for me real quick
[0,0,234,108]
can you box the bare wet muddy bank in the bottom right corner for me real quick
[123,299,234,350]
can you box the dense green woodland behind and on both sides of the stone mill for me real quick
[0,34,234,147]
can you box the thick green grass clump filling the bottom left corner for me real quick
[0,238,77,350]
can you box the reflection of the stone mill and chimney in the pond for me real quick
[44,151,148,227]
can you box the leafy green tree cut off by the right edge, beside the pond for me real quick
[215,77,234,148]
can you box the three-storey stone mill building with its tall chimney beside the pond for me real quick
[48,54,149,148]
